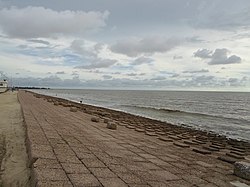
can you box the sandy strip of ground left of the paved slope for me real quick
[0,92,29,187]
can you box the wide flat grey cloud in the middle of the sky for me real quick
[110,37,181,57]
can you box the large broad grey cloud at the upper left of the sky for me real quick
[0,6,109,38]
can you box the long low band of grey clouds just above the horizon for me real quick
[10,76,250,89]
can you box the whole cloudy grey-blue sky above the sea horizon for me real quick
[0,0,250,91]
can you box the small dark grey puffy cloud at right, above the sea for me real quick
[194,48,241,65]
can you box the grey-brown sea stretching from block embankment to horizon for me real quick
[33,89,250,142]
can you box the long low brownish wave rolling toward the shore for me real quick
[120,105,250,123]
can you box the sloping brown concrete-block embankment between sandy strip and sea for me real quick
[18,91,250,187]
